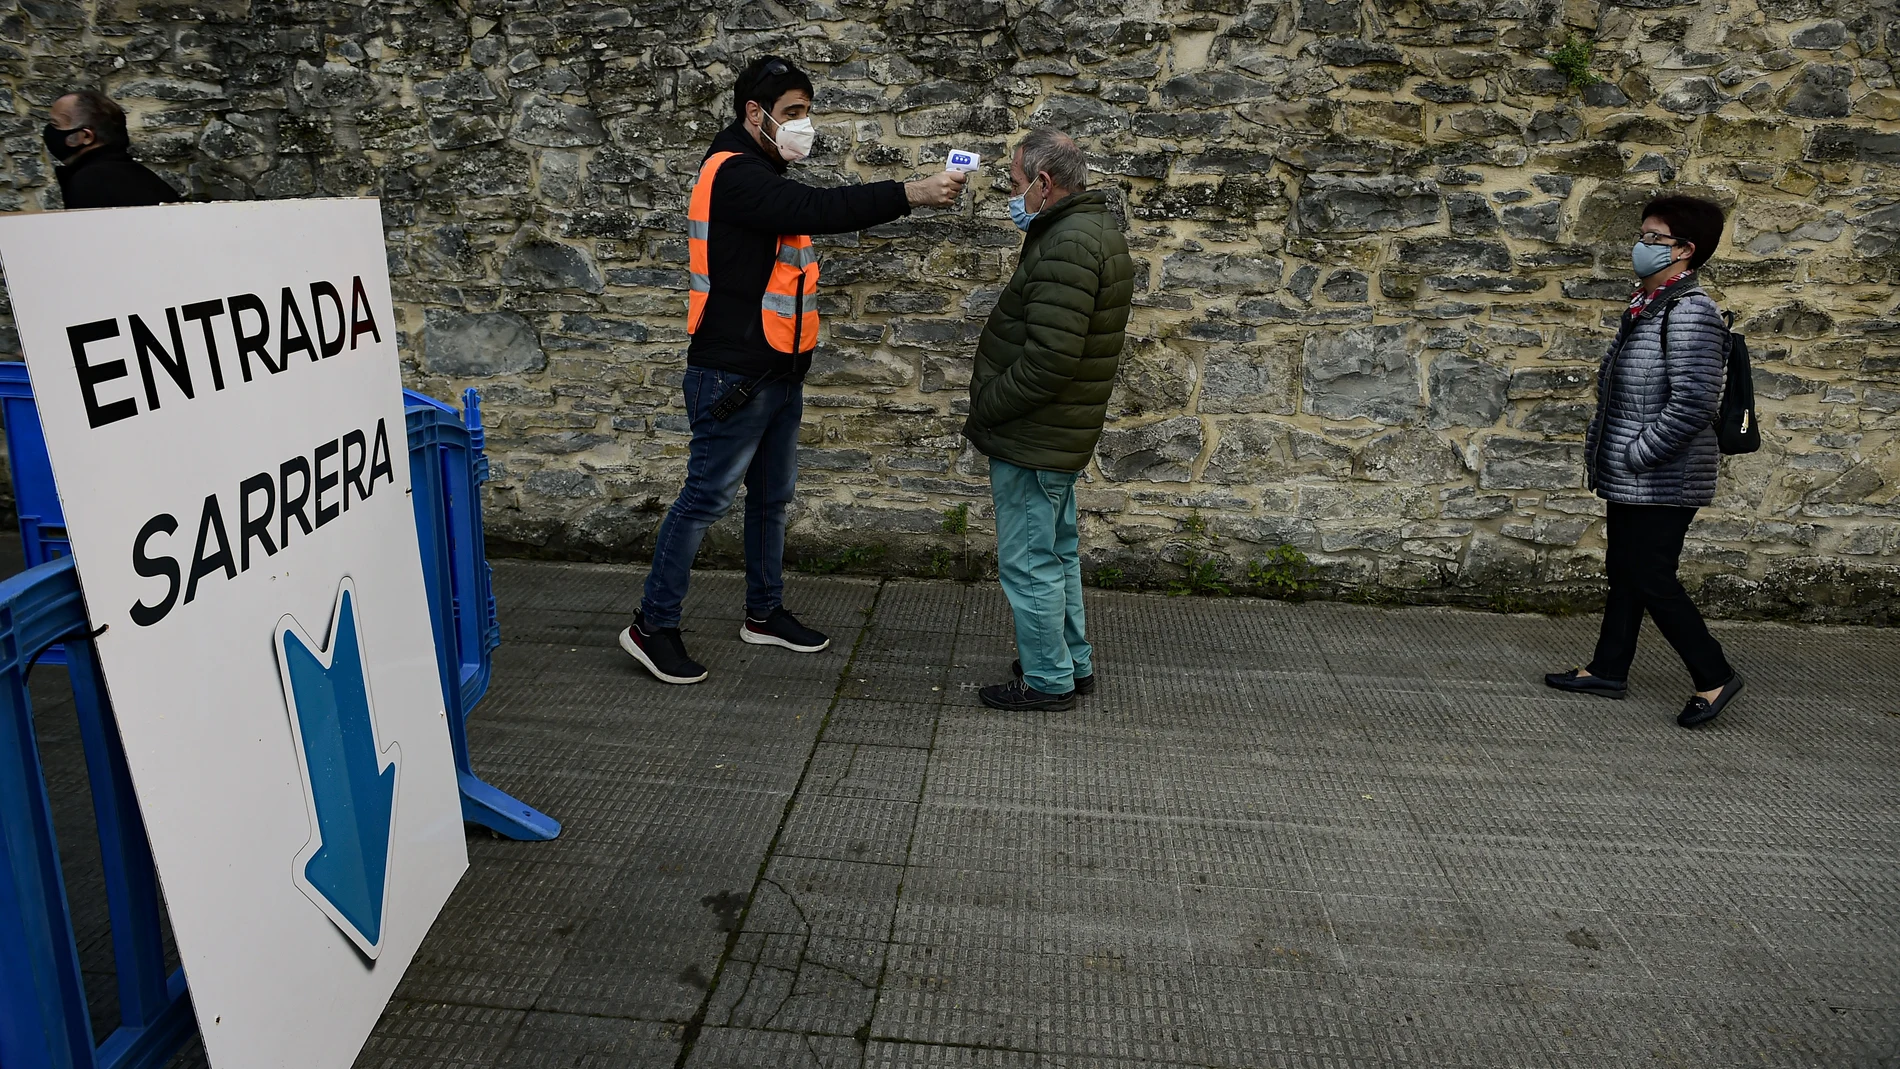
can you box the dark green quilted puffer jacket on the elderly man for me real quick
[963,192,1134,471]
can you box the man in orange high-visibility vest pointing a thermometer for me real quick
[619,55,963,684]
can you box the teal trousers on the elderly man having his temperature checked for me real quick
[990,459,1094,695]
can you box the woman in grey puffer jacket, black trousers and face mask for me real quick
[1545,196,1742,727]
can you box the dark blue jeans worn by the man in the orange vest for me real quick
[640,368,806,627]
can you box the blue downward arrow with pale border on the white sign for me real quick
[276,575,401,961]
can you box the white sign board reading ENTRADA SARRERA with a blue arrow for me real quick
[0,199,467,1069]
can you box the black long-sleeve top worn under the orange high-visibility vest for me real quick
[686,123,910,380]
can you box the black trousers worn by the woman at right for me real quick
[1590,501,1735,691]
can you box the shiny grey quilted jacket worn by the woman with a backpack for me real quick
[1583,275,1729,509]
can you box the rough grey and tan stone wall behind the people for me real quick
[0,0,1900,621]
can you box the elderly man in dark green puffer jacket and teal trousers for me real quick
[963,129,1134,710]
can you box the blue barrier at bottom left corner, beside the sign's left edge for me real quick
[0,556,198,1069]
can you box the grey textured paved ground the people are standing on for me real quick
[18,562,1900,1069]
